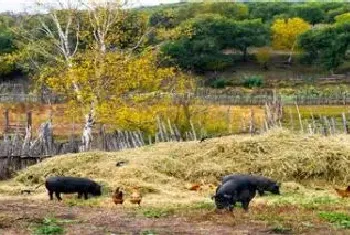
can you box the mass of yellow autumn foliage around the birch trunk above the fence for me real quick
[41,48,194,133]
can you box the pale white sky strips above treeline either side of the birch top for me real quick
[0,0,178,13]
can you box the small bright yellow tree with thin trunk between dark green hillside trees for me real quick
[271,18,310,63]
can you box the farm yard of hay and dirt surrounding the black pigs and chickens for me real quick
[0,130,350,234]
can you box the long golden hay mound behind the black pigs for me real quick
[0,131,350,206]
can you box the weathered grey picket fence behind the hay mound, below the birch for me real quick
[0,114,202,180]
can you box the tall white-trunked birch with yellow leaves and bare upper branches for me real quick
[14,0,186,150]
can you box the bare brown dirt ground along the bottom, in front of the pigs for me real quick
[0,196,346,235]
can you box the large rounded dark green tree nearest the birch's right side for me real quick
[161,14,233,72]
